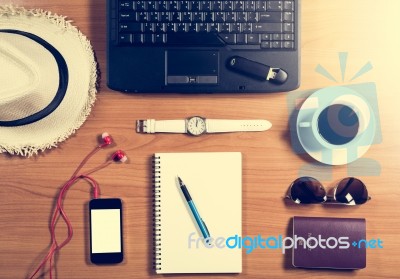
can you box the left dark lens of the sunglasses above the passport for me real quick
[290,177,326,203]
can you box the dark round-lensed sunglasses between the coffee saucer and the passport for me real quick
[287,176,371,205]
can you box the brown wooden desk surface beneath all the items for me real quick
[0,0,400,279]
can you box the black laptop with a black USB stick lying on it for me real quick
[107,0,300,93]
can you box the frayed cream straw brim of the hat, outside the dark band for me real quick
[0,5,97,156]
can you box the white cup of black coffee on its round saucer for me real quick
[296,86,375,165]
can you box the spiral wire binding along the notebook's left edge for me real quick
[152,156,161,270]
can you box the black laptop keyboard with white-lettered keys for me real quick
[117,0,297,50]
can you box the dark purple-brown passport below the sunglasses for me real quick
[292,216,366,269]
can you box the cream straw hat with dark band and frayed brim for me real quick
[0,5,97,156]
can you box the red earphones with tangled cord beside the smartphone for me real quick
[29,132,128,279]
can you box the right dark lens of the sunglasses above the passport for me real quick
[335,177,368,204]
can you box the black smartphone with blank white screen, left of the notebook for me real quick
[89,199,124,264]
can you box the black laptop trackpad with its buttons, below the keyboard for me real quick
[165,50,219,85]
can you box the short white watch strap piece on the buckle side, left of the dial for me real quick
[138,119,186,134]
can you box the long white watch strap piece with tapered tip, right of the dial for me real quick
[206,119,272,133]
